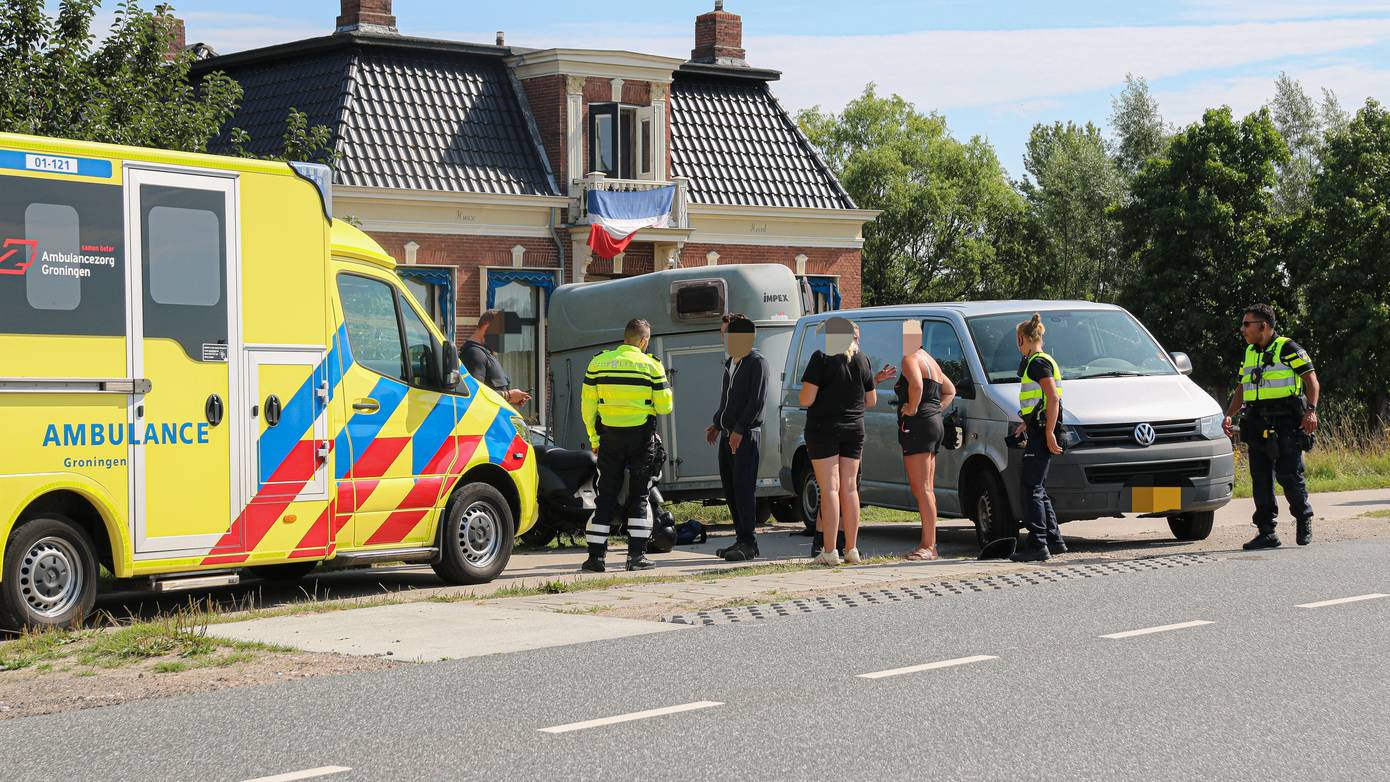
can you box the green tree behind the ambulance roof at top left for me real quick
[0,0,329,160]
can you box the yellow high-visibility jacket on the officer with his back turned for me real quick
[580,344,673,447]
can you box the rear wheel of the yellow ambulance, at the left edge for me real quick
[0,514,97,629]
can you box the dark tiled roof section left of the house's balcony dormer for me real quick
[197,33,559,196]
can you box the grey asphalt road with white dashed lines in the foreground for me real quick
[0,539,1390,782]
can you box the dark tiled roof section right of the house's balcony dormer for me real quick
[670,65,856,210]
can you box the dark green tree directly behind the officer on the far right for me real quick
[1116,107,1289,394]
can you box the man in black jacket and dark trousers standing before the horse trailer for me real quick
[705,315,767,563]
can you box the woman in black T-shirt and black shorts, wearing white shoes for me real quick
[801,318,897,565]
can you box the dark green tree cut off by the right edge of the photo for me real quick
[1300,100,1390,425]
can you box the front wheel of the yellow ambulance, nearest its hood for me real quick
[434,483,516,583]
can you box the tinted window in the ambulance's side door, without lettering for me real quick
[140,185,228,361]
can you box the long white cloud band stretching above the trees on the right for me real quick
[745,19,1390,110]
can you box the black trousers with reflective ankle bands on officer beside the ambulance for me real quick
[584,418,656,560]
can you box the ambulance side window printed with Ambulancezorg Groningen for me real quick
[0,175,126,336]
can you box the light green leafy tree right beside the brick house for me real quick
[798,85,1024,304]
